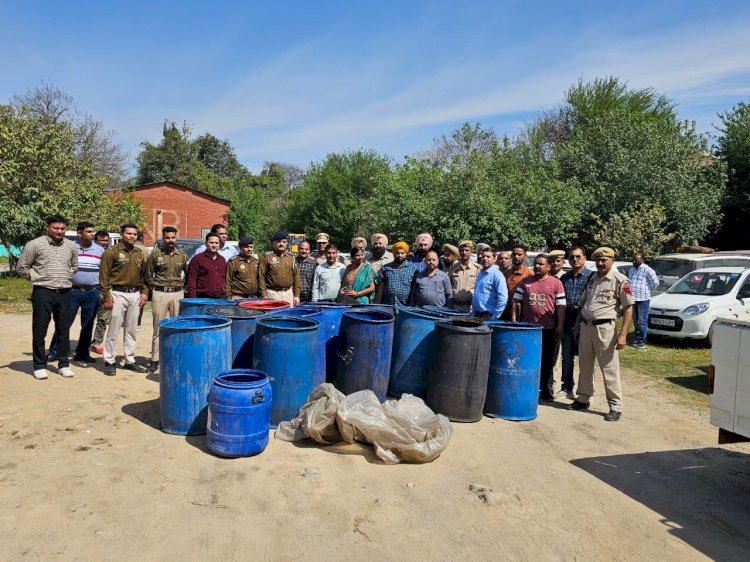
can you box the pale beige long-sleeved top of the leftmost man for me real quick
[16,234,78,289]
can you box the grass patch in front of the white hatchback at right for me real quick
[618,322,711,411]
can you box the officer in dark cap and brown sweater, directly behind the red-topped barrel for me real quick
[258,230,300,306]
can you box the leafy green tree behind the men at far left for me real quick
[0,106,143,261]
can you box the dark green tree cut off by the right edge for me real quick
[716,102,750,248]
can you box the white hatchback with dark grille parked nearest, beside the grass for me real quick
[648,267,750,343]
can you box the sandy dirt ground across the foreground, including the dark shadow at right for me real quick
[0,312,750,561]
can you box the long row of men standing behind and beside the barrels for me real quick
[18,216,658,421]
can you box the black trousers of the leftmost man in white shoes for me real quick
[31,287,70,371]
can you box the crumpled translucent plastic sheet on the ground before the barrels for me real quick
[276,383,453,464]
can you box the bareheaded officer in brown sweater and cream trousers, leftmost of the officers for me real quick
[99,224,148,376]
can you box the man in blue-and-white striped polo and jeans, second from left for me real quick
[47,221,104,365]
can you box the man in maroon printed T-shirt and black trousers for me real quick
[511,254,565,400]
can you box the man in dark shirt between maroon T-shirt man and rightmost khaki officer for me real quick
[560,246,594,400]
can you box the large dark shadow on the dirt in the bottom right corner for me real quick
[570,447,750,560]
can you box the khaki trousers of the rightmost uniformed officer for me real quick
[576,322,622,412]
